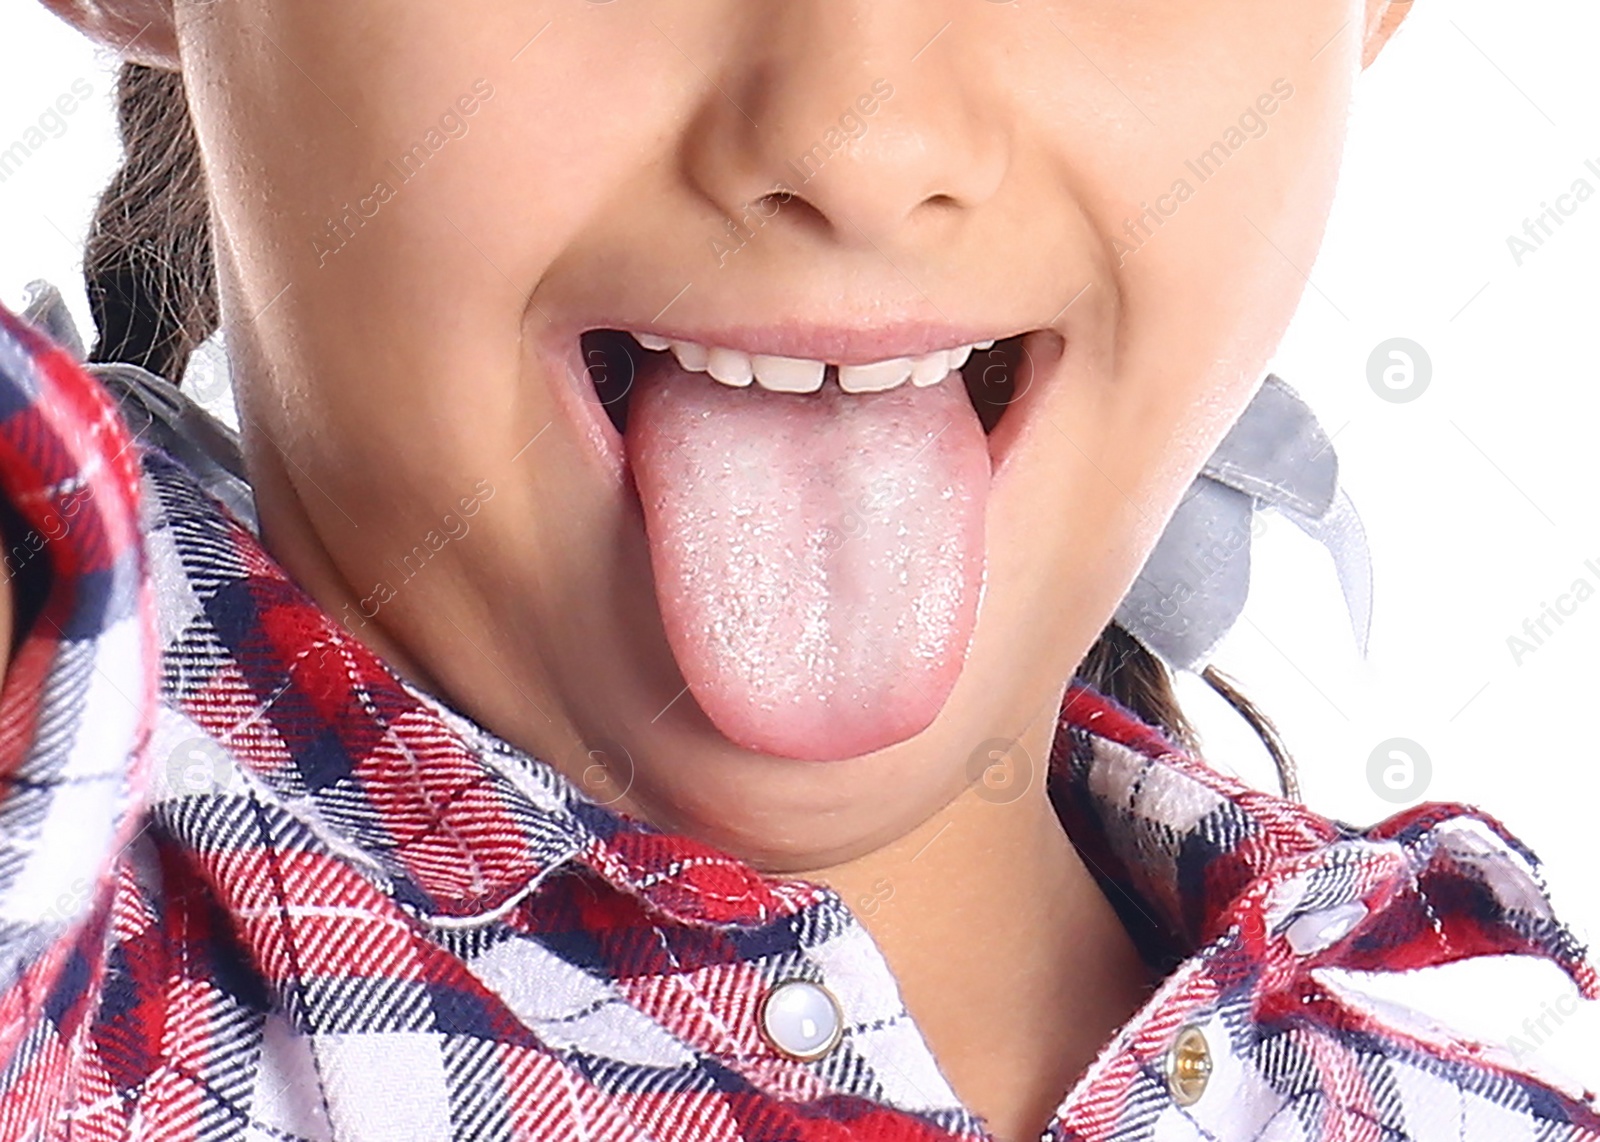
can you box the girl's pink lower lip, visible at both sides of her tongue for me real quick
[536,328,1066,494]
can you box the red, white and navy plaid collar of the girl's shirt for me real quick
[144,451,1600,995]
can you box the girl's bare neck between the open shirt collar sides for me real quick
[803,703,1154,1142]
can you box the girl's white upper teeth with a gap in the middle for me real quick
[634,333,995,392]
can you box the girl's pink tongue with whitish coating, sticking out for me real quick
[627,353,989,760]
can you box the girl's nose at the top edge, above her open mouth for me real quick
[686,0,1006,246]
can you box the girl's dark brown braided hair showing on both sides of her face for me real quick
[83,64,1299,798]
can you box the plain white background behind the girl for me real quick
[9,0,1600,1086]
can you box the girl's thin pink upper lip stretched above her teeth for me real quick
[616,321,1016,365]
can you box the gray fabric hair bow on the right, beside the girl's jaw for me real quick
[1115,376,1373,672]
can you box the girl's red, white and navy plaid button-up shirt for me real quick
[0,295,1600,1142]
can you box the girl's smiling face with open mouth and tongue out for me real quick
[159,0,1387,868]
